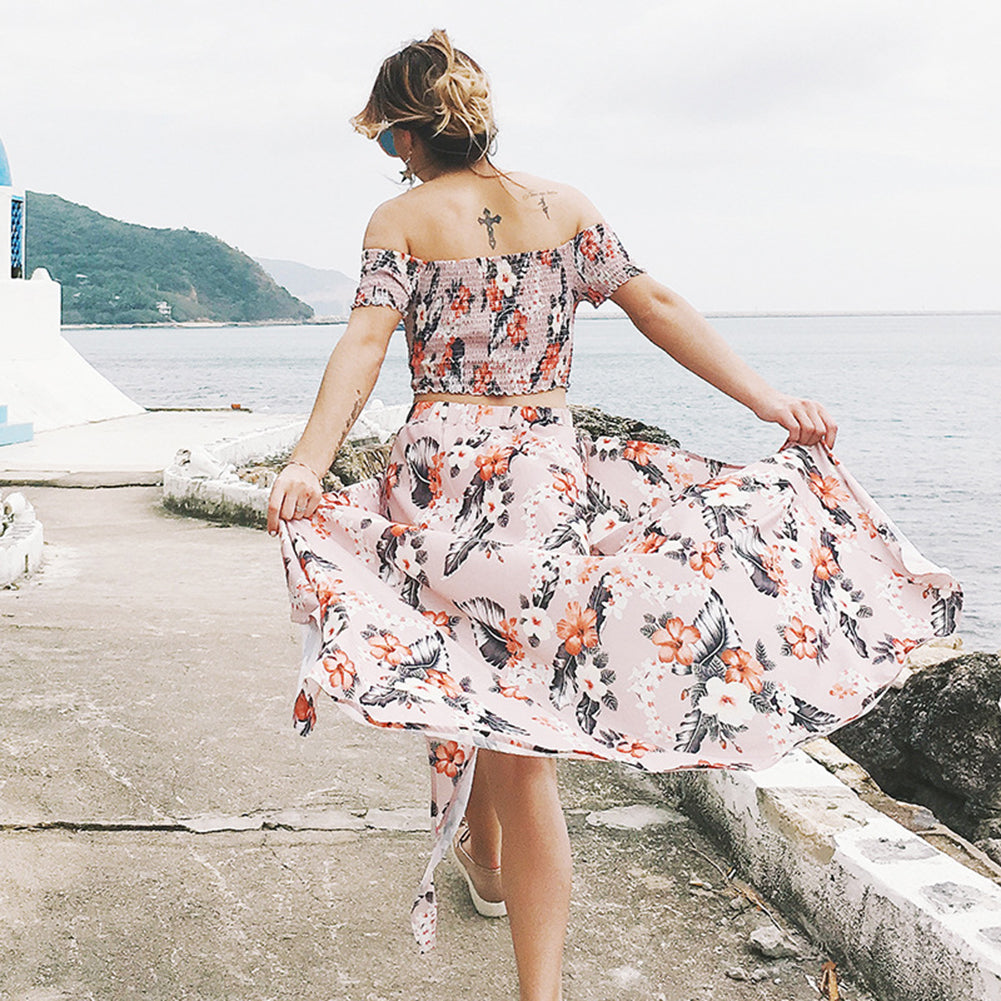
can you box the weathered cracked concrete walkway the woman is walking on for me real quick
[0,486,872,1001]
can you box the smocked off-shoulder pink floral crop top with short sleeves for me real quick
[354,222,643,396]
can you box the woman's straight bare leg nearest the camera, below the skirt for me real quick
[469,749,572,1001]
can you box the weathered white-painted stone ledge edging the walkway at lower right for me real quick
[658,750,1001,1001]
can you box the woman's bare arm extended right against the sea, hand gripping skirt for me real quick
[611,274,838,448]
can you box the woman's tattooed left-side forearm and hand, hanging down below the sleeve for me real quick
[267,306,401,536]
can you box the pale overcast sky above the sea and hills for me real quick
[0,0,1001,310]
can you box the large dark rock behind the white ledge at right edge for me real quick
[830,654,1001,862]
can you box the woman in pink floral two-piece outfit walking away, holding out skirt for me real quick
[268,31,960,1001]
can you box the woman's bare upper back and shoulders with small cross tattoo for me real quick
[364,164,601,261]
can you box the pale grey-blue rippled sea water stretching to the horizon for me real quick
[66,310,1001,651]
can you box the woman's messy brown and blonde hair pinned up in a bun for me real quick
[351,29,496,166]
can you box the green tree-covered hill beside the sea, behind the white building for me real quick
[25,191,313,323]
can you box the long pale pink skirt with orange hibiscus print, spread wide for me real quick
[281,402,962,951]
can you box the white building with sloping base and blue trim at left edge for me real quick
[0,140,143,438]
